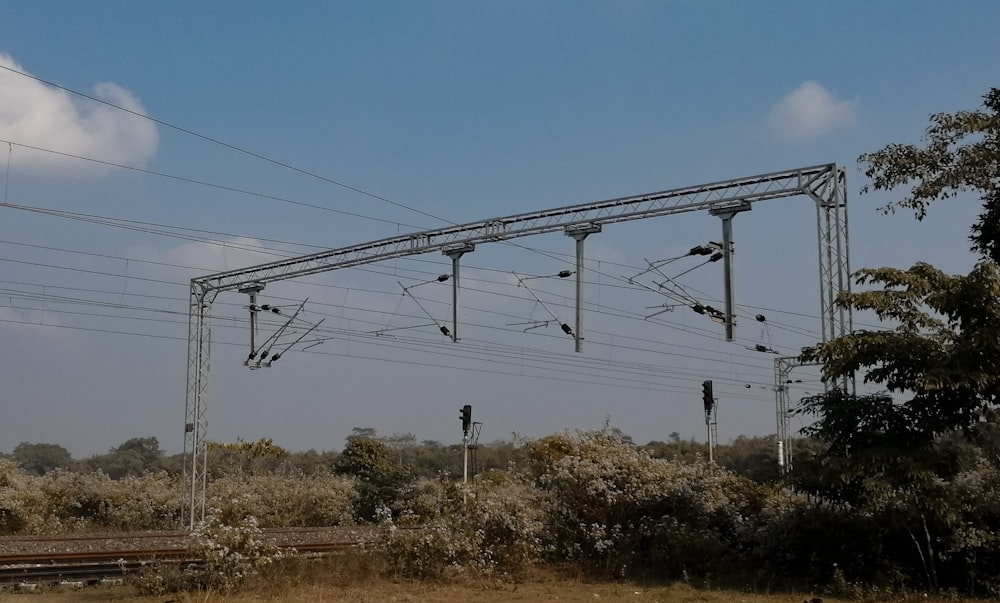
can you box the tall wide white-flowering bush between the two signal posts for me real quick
[530,431,767,577]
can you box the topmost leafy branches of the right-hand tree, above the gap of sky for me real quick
[859,88,1000,262]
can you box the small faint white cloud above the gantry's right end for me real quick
[768,82,854,140]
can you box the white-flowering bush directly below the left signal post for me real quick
[372,479,543,580]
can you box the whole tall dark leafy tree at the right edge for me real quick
[799,89,1000,588]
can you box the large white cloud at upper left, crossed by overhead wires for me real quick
[0,53,159,176]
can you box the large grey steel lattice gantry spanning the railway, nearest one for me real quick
[183,164,850,527]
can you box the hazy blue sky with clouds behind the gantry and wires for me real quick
[0,0,1000,456]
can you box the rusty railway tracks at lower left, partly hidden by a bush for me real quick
[0,527,371,587]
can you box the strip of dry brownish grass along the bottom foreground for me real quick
[0,555,968,603]
